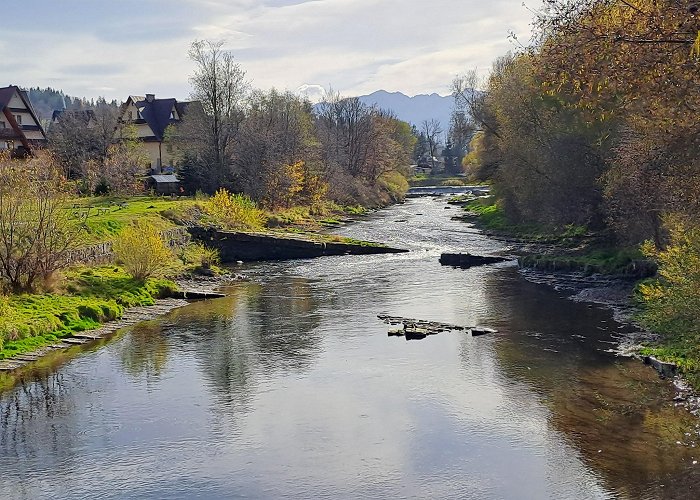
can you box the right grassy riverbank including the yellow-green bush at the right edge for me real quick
[464,198,700,390]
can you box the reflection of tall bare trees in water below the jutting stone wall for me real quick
[174,276,320,407]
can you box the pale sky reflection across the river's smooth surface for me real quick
[0,201,632,498]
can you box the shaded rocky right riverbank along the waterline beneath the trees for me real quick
[453,194,700,402]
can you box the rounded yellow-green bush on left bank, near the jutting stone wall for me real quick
[112,223,176,281]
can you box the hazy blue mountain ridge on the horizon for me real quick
[360,90,454,131]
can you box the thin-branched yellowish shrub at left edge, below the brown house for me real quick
[0,152,80,293]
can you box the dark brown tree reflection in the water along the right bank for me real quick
[474,271,693,497]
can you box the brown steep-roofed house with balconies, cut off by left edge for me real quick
[0,85,46,156]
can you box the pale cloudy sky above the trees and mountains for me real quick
[0,0,532,101]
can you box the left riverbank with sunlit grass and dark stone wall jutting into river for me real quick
[0,197,403,370]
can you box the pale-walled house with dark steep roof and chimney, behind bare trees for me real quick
[118,94,199,175]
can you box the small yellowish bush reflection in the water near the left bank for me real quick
[120,321,168,379]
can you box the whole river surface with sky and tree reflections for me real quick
[0,198,700,499]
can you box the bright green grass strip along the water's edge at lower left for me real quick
[0,266,176,359]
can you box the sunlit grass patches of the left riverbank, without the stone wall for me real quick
[0,196,382,359]
